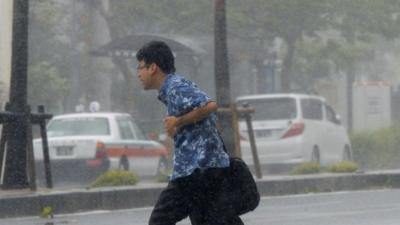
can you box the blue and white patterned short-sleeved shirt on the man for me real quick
[158,74,229,180]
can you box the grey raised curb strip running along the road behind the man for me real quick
[0,170,400,218]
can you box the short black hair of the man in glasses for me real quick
[136,41,175,74]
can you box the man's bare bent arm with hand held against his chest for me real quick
[164,101,218,137]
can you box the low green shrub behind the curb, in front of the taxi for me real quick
[90,170,139,188]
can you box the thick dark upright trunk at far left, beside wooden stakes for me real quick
[3,0,30,189]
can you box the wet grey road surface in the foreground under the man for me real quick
[0,190,400,225]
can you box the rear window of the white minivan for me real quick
[238,98,297,120]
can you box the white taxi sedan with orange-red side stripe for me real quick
[34,113,168,181]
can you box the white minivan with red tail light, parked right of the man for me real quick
[236,94,352,165]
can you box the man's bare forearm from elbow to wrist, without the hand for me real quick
[177,102,218,128]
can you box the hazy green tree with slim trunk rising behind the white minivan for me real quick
[228,0,400,91]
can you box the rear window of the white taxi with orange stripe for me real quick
[47,117,110,137]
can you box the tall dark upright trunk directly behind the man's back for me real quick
[214,0,235,155]
